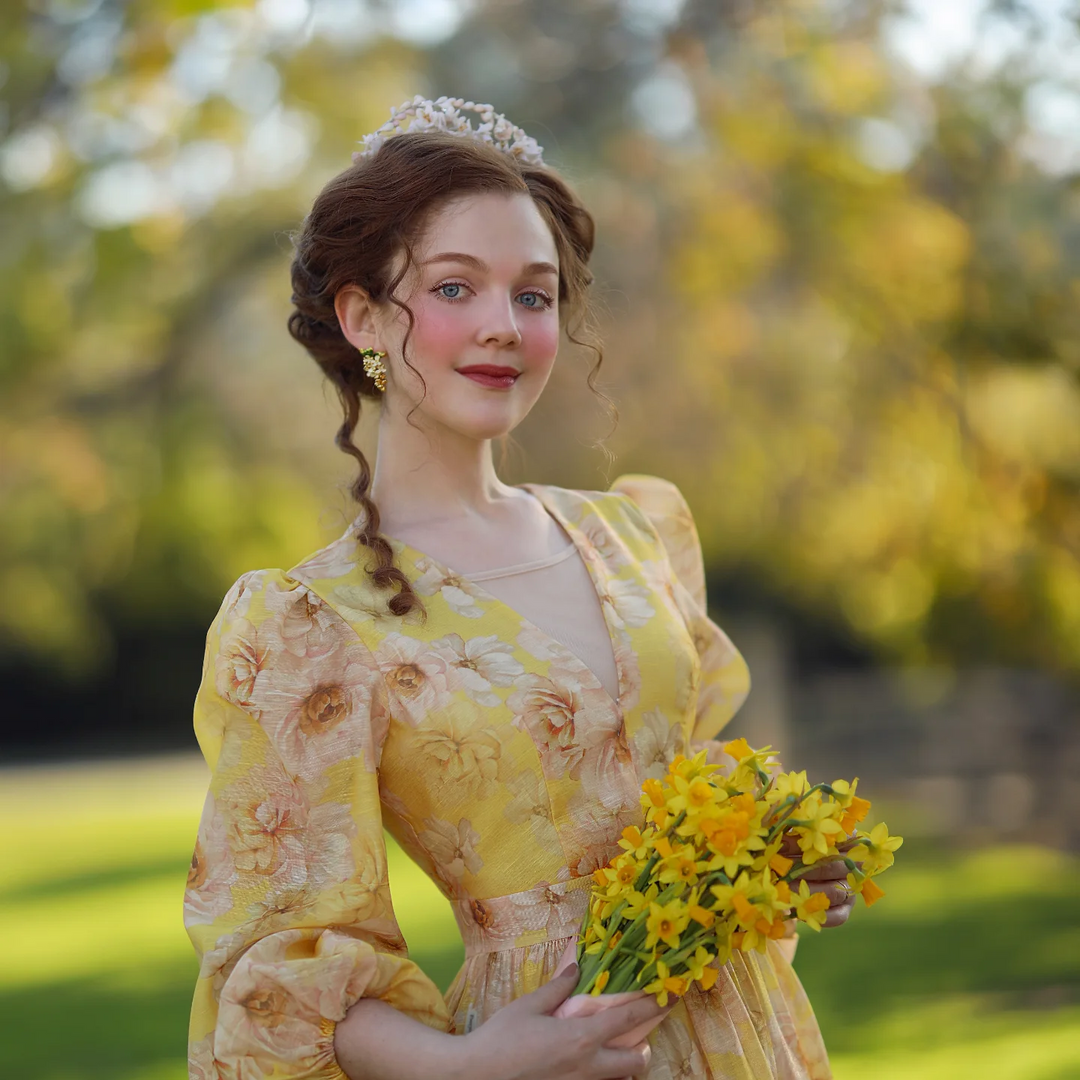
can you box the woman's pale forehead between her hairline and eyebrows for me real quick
[416,192,558,266]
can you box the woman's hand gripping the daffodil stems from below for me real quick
[461,964,667,1080]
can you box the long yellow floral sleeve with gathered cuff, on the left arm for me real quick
[185,570,449,1080]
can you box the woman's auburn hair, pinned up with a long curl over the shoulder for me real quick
[288,132,603,616]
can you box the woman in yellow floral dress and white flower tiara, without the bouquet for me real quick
[186,98,851,1080]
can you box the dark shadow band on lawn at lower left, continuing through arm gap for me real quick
[0,946,461,1080]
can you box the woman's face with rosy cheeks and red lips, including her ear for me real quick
[373,193,559,440]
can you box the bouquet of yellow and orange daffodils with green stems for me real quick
[568,739,903,1005]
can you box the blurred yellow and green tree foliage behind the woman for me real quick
[0,0,1080,756]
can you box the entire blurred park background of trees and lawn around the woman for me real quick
[0,0,1080,1080]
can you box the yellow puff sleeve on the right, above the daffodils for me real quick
[611,474,750,743]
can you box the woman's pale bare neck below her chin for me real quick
[370,404,519,537]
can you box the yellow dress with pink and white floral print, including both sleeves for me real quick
[185,475,831,1080]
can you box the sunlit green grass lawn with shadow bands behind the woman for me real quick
[0,757,1080,1080]
